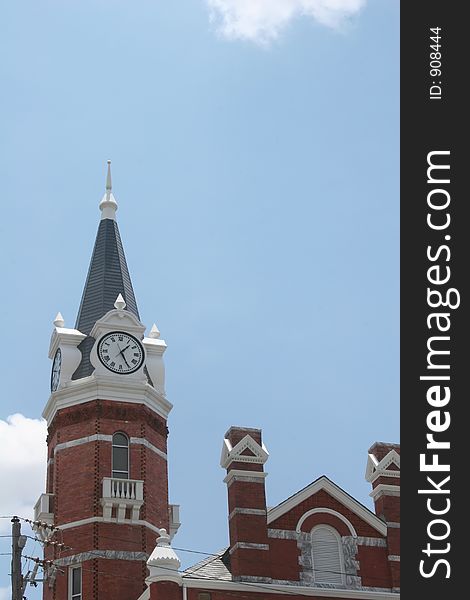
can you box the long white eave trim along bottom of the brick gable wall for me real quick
[178,575,397,600]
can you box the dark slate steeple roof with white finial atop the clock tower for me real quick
[72,161,140,379]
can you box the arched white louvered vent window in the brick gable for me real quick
[312,525,343,584]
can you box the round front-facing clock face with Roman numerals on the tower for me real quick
[98,331,144,375]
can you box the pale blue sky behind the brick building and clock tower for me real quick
[0,0,399,600]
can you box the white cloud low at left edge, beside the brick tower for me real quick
[0,414,47,536]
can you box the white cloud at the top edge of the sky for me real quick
[206,0,367,44]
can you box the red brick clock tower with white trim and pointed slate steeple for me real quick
[35,162,179,600]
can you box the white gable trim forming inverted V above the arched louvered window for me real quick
[268,475,387,536]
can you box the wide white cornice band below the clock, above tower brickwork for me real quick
[42,373,173,425]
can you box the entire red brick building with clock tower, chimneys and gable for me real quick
[35,165,400,600]
